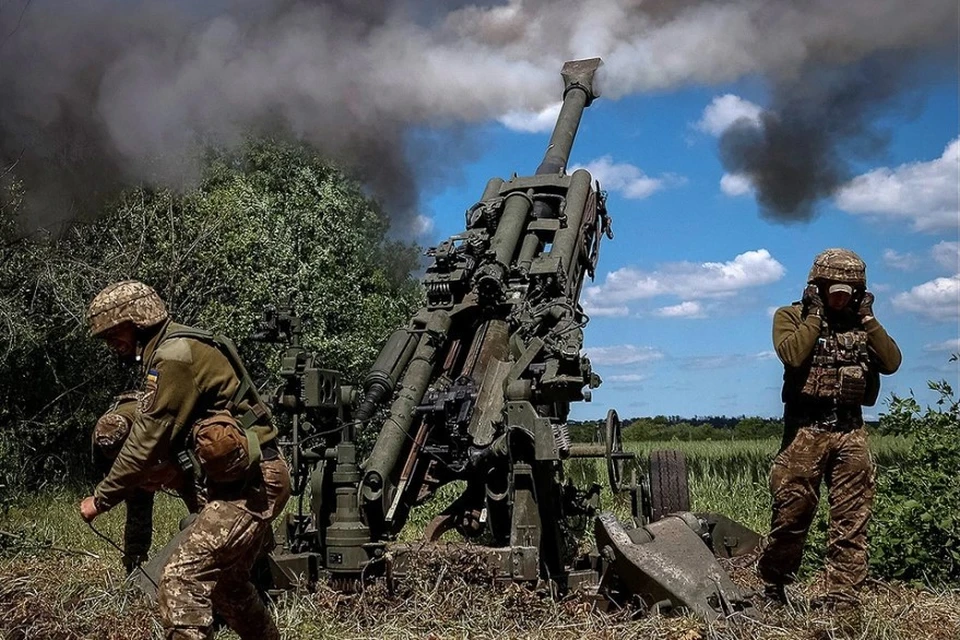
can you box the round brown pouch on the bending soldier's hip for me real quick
[192,411,260,482]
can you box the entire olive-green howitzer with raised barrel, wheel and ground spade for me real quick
[141,58,757,617]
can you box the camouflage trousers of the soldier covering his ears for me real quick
[757,425,875,595]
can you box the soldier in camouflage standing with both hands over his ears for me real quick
[758,249,901,604]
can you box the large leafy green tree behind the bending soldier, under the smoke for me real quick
[0,141,422,484]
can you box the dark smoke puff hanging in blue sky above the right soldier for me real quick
[720,53,929,223]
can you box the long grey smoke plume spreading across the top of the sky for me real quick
[0,0,957,232]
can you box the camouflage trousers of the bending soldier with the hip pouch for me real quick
[157,458,290,640]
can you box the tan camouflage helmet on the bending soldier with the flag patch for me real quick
[87,280,170,336]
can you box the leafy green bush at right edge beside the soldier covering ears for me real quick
[870,355,960,586]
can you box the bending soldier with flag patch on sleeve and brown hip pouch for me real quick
[80,281,290,640]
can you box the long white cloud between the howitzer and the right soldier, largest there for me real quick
[585,249,785,306]
